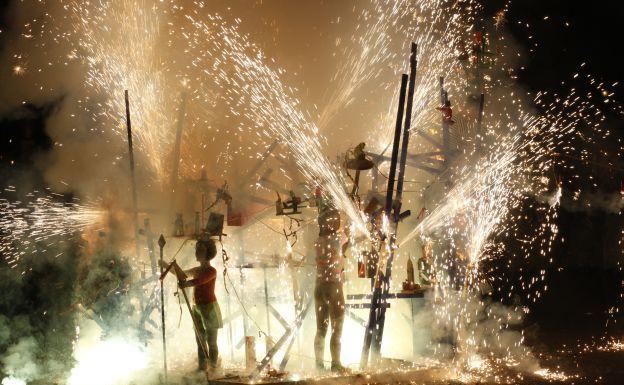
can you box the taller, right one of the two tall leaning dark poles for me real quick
[373,43,418,354]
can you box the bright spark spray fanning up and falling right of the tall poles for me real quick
[400,61,620,370]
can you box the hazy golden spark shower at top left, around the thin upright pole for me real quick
[70,0,176,176]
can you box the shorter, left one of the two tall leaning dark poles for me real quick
[360,74,408,369]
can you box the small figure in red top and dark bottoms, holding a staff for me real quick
[180,239,223,370]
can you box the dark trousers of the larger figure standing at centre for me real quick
[314,282,345,366]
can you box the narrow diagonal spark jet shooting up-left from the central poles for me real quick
[178,15,366,231]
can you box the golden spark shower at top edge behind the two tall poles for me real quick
[330,0,479,151]
